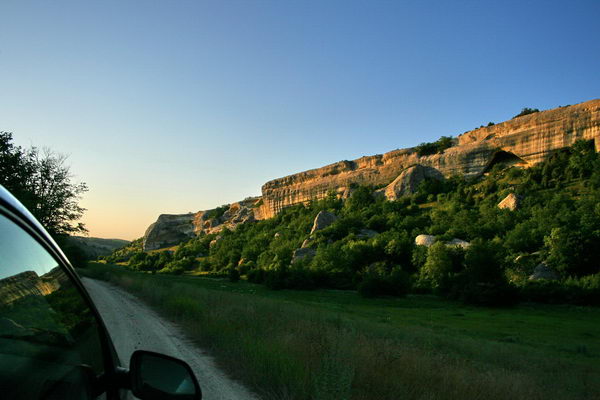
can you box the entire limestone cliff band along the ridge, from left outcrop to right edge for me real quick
[144,99,600,250]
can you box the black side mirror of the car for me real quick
[129,350,202,400]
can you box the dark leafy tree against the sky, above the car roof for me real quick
[0,132,88,236]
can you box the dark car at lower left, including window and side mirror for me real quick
[0,185,202,400]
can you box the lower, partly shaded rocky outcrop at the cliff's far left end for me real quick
[143,197,262,251]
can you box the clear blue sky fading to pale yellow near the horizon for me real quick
[0,0,600,239]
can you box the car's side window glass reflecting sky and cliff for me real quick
[0,215,103,399]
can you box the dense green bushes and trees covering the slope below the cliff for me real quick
[105,141,600,306]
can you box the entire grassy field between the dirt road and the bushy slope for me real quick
[82,263,600,400]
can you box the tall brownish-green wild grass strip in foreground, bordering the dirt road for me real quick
[83,266,600,400]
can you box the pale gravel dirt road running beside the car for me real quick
[83,278,257,400]
